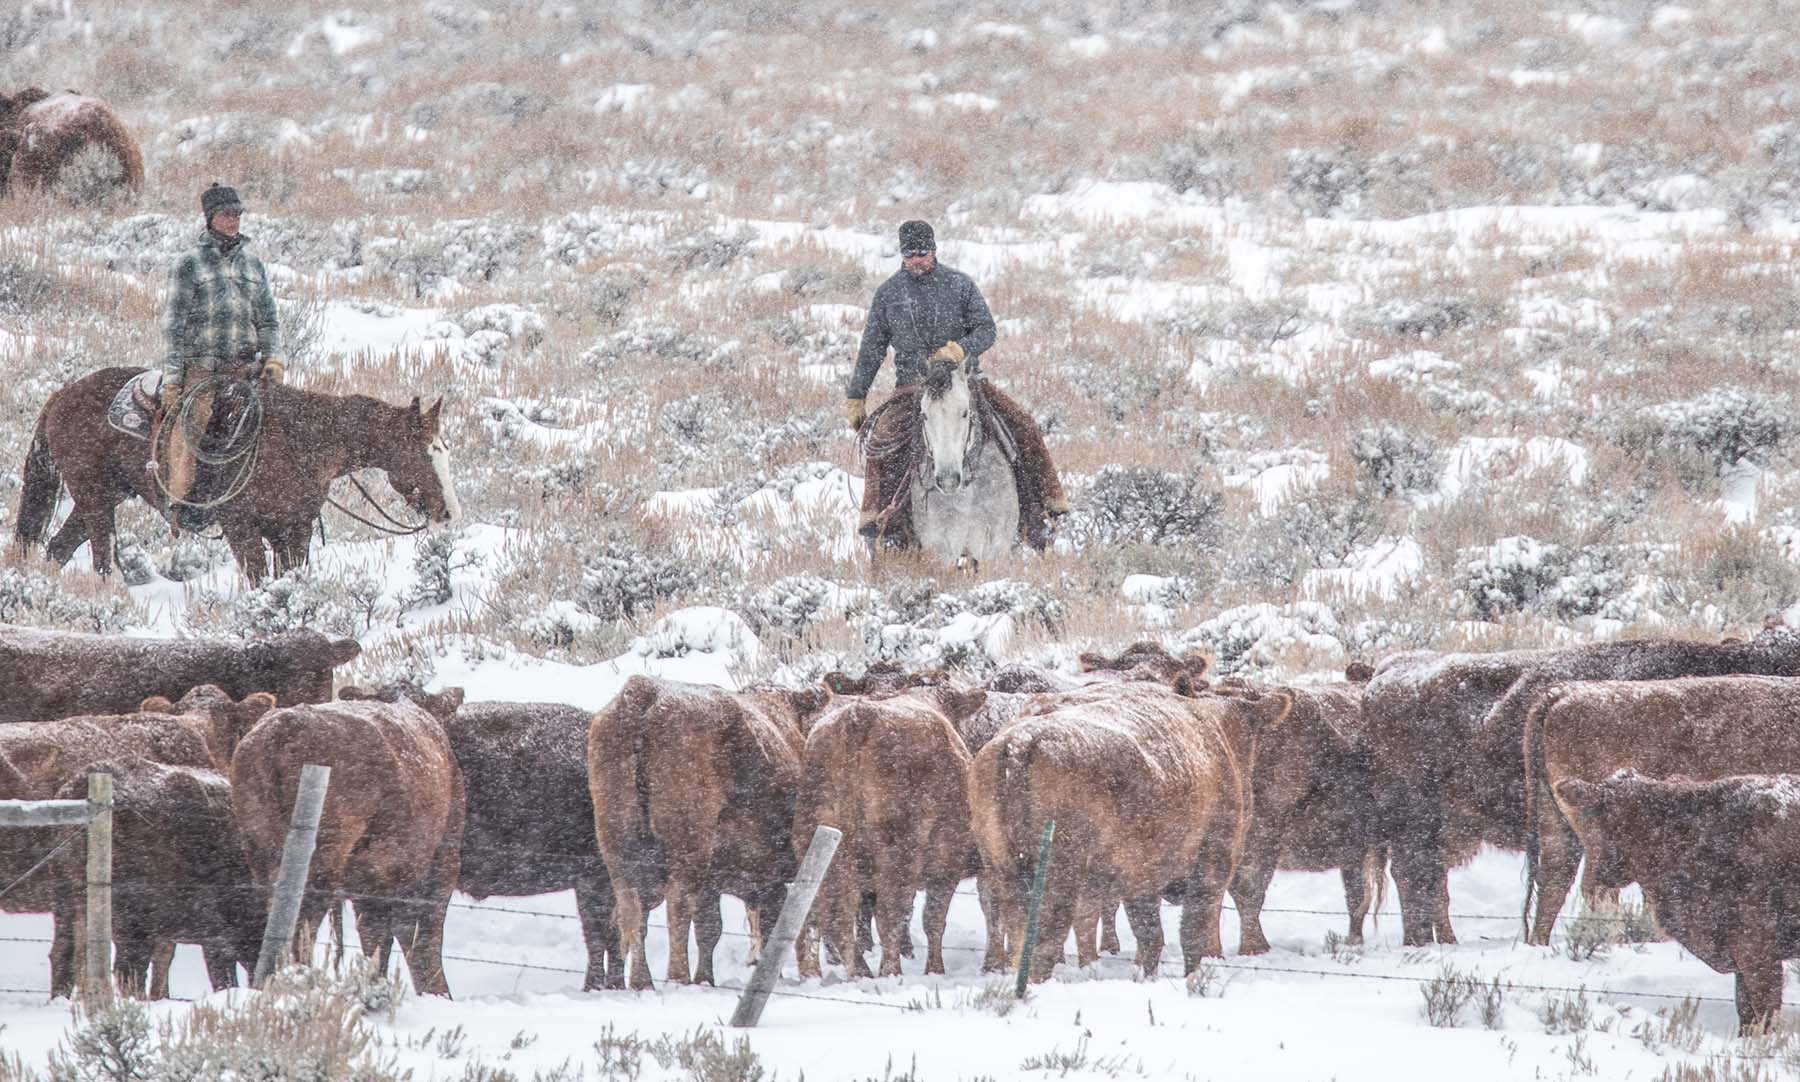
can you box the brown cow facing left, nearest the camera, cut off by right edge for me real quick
[1555,771,1800,1033]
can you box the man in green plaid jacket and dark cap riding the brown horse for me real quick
[160,182,286,529]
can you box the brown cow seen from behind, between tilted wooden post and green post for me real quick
[794,688,997,978]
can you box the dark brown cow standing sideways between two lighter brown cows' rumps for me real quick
[338,684,625,992]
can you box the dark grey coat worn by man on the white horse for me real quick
[844,263,994,398]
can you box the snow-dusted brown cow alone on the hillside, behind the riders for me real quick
[0,86,144,194]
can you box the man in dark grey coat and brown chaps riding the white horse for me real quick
[846,220,1069,547]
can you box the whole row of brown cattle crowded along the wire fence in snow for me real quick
[0,628,1800,1026]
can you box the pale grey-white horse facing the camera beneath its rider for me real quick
[913,371,1019,564]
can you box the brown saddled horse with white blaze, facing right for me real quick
[14,367,457,582]
